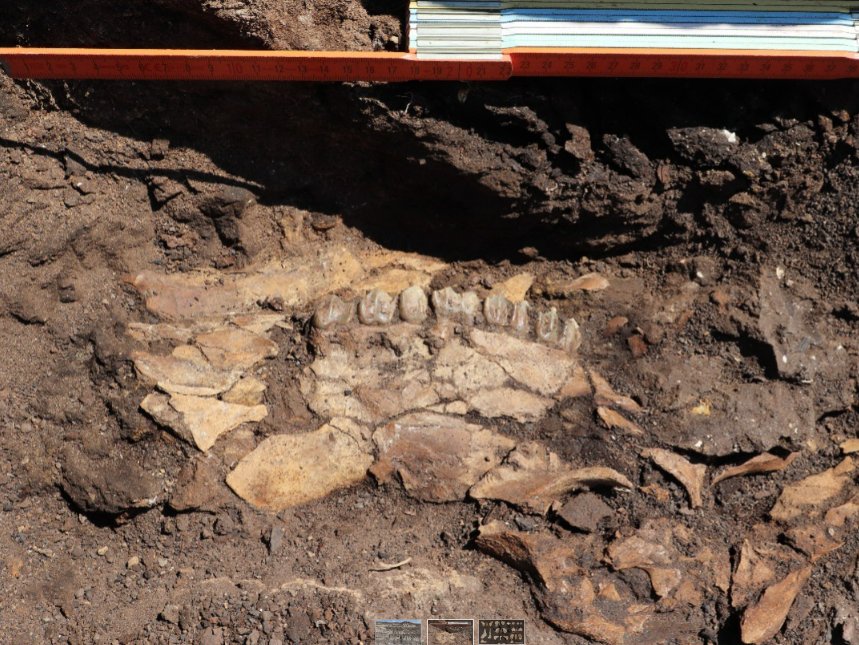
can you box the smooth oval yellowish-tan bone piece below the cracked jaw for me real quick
[227,419,373,511]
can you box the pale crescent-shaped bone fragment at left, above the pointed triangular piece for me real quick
[131,352,240,396]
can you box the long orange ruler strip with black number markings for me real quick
[0,48,859,81]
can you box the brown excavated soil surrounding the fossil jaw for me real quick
[0,0,859,645]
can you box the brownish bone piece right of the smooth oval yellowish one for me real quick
[371,412,515,502]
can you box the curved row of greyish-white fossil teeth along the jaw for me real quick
[313,287,581,351]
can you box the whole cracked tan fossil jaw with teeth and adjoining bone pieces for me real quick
[128,250,640,513]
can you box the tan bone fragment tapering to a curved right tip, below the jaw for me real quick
[468,442,633,515]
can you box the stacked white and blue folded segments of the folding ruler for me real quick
[409,0,859,59]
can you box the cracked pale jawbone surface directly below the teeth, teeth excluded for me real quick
[301,314,577,424]
